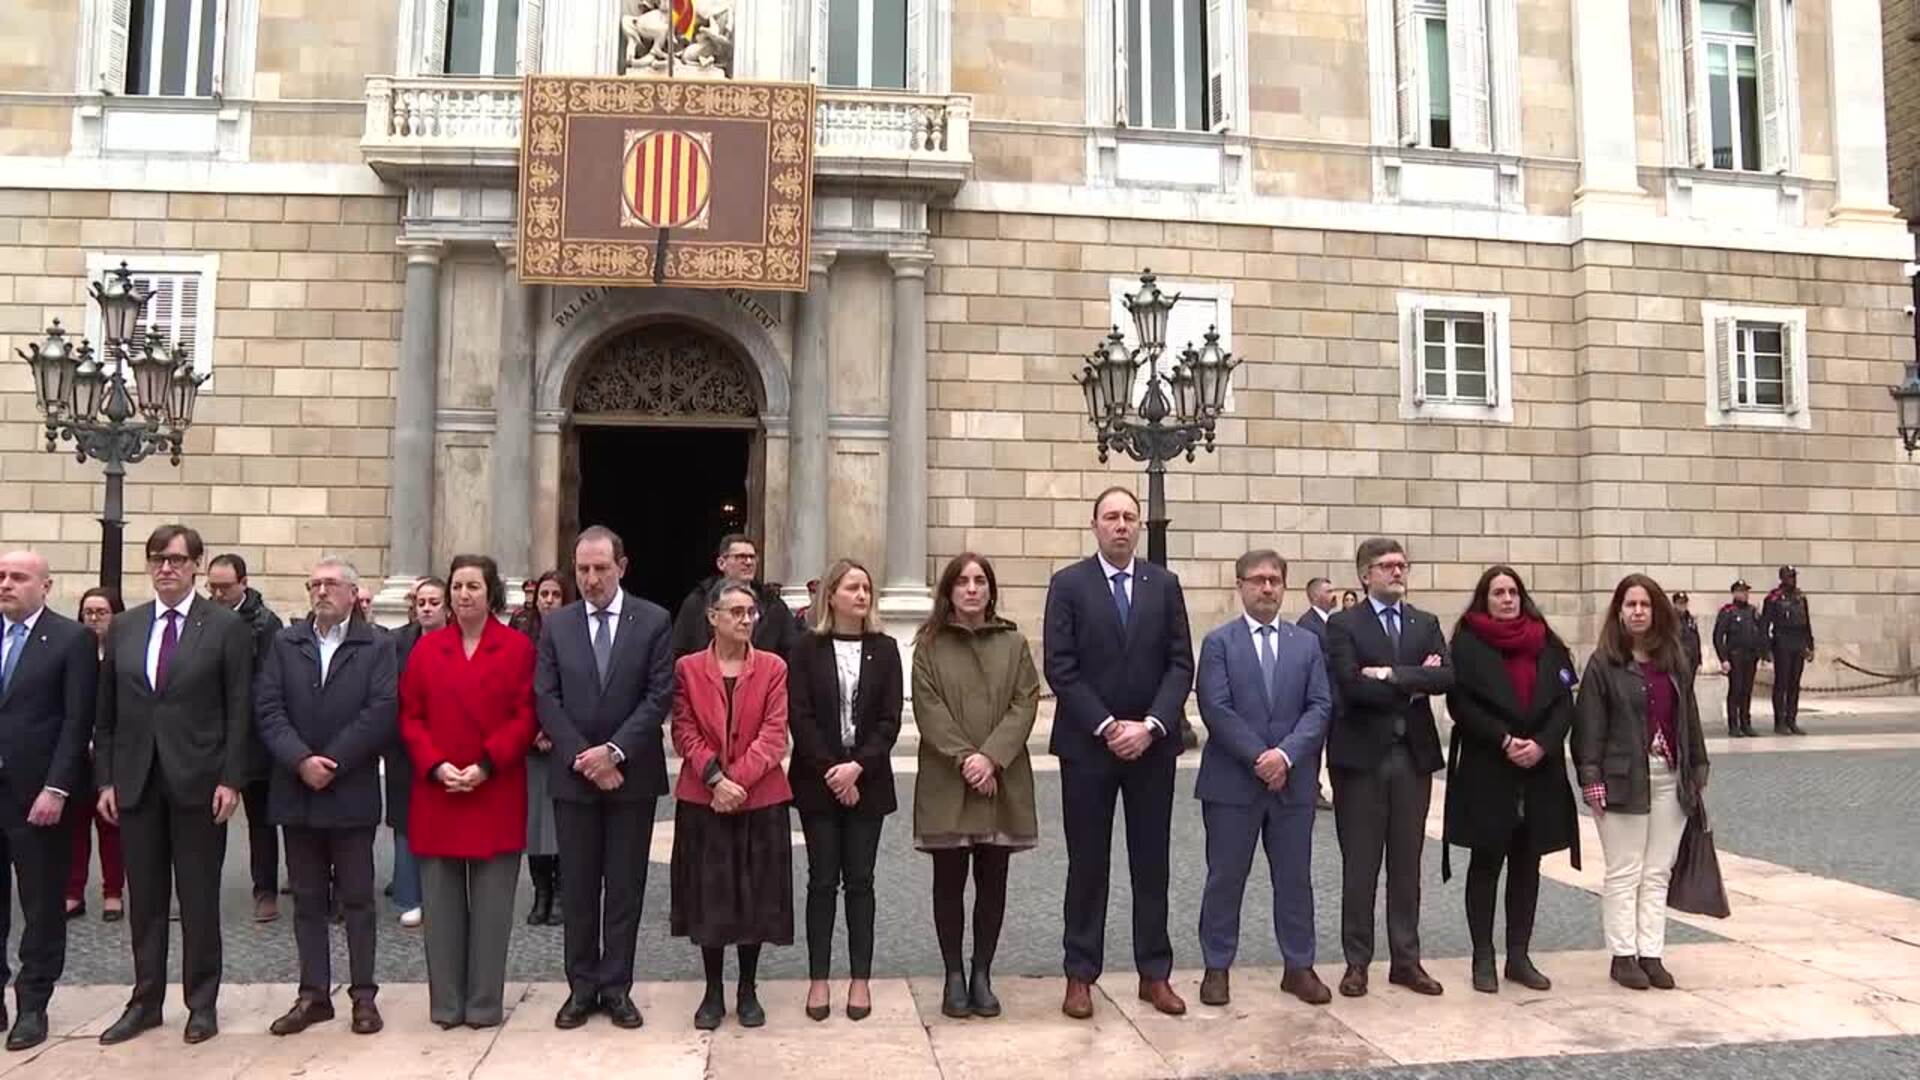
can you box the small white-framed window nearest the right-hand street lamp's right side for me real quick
[1396,292,1513,423]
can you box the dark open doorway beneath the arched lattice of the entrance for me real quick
[576,425,758,611]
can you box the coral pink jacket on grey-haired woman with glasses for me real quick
[674,646,793,809]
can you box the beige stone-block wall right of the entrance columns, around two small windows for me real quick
[927,213,1920,663]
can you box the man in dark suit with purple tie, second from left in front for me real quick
[94,525,253,1045]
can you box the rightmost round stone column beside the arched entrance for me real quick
[879,252,933,623]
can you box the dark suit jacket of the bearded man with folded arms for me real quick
[1327,600,1453,773]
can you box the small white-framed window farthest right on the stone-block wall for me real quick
[1701,304,1811,429]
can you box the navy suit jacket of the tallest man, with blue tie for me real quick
[1041,555,1194,765]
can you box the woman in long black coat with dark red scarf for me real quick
[1442,567,1580,994]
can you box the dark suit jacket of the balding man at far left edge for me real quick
[0,607,100,824]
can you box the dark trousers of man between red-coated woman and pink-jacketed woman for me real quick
[553,799,657,1001]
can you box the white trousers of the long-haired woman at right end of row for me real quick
[1599,755,1686,959]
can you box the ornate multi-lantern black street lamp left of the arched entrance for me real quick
[13,263,207,588]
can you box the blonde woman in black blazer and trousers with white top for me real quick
[787,559,902,1020]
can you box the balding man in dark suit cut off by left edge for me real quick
[0,552,98,1049]
